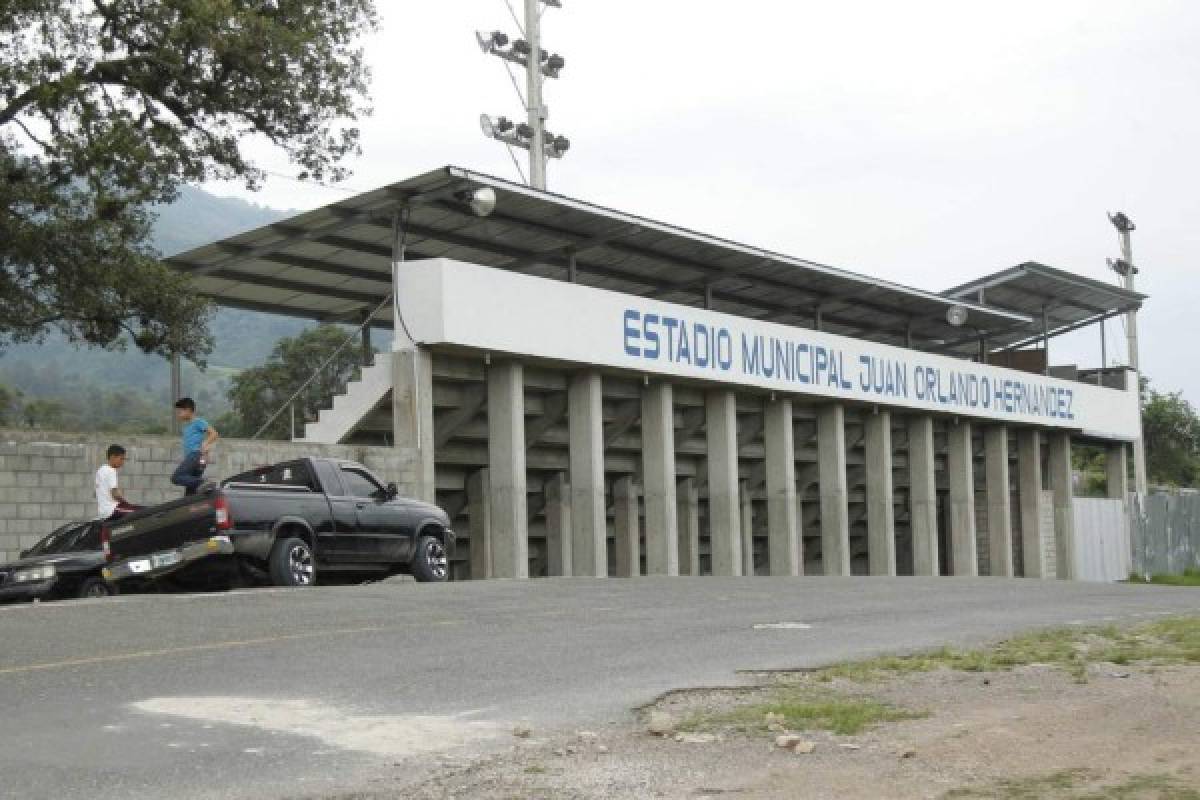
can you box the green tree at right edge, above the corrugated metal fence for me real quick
[1141,383,1200,486]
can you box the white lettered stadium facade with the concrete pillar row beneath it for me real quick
[290,260,1135,578]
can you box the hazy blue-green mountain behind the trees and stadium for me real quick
[0,187,312,432]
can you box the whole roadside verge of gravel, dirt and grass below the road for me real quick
[346,618,1200,800]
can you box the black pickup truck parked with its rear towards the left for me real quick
[101,458,455,587]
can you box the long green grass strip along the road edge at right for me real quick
[815,616,1200,682]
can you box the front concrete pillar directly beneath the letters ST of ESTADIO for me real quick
[642,380,679,575]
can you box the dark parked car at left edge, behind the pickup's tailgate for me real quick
[0,521,114,601]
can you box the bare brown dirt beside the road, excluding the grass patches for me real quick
[369,664,1200,800]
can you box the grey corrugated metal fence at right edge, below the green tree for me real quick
[1130,494,1200,575]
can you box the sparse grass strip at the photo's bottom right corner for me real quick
[942,769,1200,800]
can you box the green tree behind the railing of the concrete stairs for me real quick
[217,325,361,439]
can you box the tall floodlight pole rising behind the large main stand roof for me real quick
[475,0,571,190]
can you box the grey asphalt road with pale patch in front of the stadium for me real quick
[0,578,1200,800]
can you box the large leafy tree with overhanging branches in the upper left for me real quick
[0,0,377,360]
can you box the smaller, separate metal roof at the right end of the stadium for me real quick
[944,261,1146,349]
